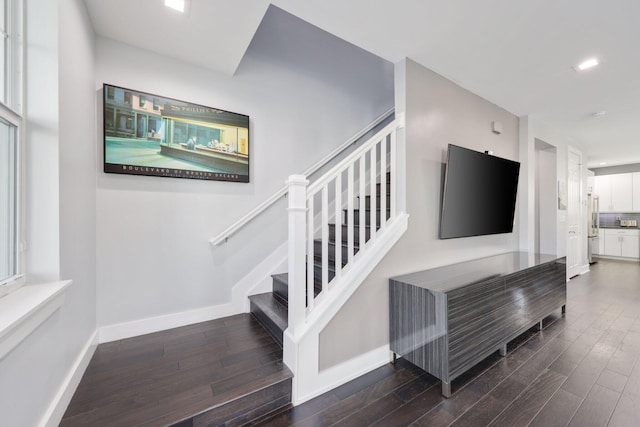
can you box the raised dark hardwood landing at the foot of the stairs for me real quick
[60,314,292,427]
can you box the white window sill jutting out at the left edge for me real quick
[0,280,71,360]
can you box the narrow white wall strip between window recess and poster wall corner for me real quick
[58,0,97,378]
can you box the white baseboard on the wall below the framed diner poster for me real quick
[98,303,242,344]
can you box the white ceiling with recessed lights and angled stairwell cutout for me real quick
[85,0,640,167]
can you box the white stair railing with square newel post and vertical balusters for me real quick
[287,115,404,336]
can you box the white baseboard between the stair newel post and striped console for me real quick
[295,344,391,405]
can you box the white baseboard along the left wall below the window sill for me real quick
[38,330,98,427]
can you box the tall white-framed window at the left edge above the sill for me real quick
[0,0,23,296]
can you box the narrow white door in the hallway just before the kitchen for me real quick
[567,149,582,278]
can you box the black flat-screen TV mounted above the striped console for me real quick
[440,144,520,239]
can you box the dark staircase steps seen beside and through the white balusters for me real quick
[249,177,391,346]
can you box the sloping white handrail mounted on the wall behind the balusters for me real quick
[209,108,395,246]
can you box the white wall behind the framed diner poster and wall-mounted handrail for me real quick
[94,8,393,332]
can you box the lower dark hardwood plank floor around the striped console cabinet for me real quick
[252,260,640,427]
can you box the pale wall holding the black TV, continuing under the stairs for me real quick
[320,60,518,369]
